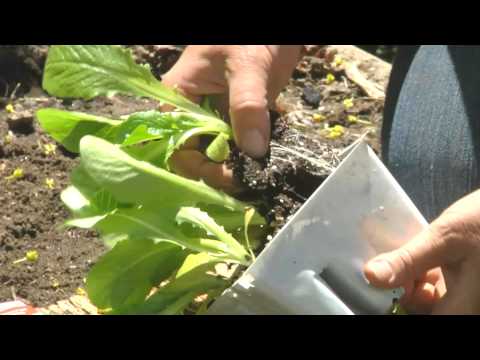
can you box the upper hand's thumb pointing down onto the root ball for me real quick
[227,63,270,158]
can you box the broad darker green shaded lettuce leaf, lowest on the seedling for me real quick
[86,239,188,309]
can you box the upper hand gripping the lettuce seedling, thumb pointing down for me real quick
[162,45,302,190]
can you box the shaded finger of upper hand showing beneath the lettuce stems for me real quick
[170,150,239,194]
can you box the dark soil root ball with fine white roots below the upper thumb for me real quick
[229,115,329,235]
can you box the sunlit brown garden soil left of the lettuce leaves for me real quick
[0,93,161,306]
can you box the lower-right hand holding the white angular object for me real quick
[365,191,480,315]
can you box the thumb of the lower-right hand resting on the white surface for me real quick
[365,226,451,288]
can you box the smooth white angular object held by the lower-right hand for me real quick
[208,141,428,315]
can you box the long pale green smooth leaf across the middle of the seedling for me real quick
[80,136,246,211]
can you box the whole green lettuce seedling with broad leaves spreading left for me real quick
[37,45,265,314]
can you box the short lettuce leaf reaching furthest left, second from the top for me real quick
[36,109,121,153]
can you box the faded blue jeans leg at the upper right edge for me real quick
[382,45,480,221]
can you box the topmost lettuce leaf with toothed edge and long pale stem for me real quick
[43,45,211,116]
